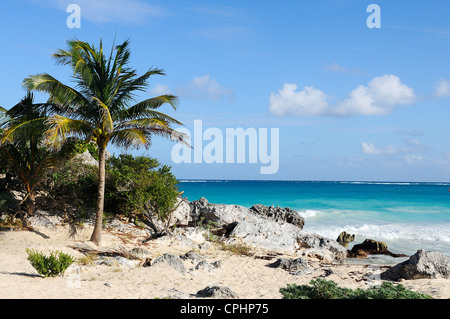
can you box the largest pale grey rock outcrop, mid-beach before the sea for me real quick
[185,198,347,263]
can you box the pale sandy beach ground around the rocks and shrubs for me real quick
[0,226,450,299]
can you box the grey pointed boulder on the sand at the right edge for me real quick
[381,250,450,281]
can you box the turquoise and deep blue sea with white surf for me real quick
[179,180,450,257]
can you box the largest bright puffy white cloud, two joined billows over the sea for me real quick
[269,74,416,116]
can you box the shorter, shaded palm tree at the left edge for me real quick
[0,92,73,227]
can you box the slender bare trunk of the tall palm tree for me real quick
[91,143,106,245]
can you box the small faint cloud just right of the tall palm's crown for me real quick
[176,75,233,101]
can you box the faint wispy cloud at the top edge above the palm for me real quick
[30,0,165,24]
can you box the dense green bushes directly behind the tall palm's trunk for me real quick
[41,152,179,226]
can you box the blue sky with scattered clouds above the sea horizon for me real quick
[0,0,450,182]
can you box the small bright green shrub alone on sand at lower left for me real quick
[26,248,75,277]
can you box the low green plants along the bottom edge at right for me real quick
[280,279,432,299]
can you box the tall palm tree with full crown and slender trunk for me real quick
[23,39,182,244]
